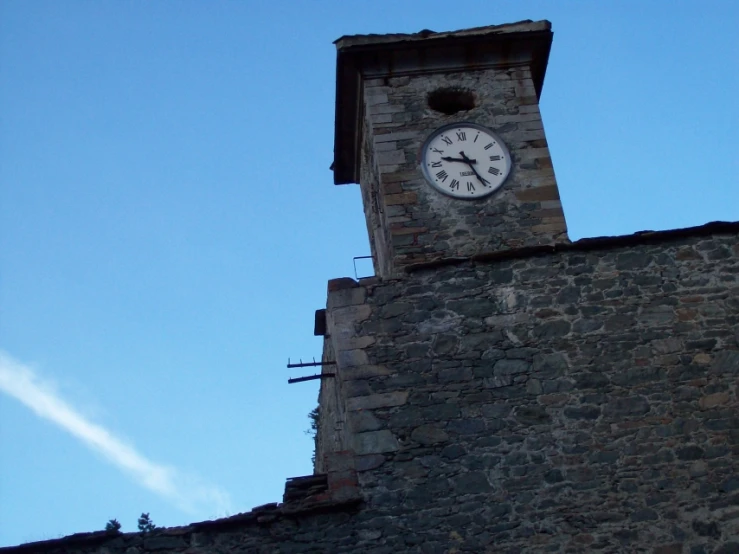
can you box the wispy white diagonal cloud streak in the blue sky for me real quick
[0,350,230,516]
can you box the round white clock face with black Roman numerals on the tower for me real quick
[421,123,511,199]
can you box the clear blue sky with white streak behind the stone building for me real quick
[0,0,739,545]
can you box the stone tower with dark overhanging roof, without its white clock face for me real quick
[333,21,568,277]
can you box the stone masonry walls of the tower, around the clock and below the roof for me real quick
[361,66,567,277]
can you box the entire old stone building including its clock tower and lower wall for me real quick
[0,21,739,554]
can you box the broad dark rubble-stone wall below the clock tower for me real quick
[316,227,739,554]
